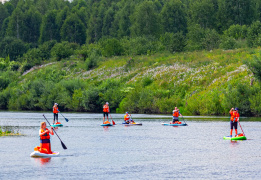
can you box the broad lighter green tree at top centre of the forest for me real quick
[131,1,161,36]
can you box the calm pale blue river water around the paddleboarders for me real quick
[0,112,261,180]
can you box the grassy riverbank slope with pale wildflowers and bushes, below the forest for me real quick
[0,48,261,115]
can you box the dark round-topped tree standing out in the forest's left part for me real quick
[61,14,86,44]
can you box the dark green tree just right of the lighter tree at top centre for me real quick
[161,0,187,33]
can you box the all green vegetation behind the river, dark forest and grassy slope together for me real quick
[0,0,261,116]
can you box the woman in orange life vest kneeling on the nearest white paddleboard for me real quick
[39,122,54,154]
